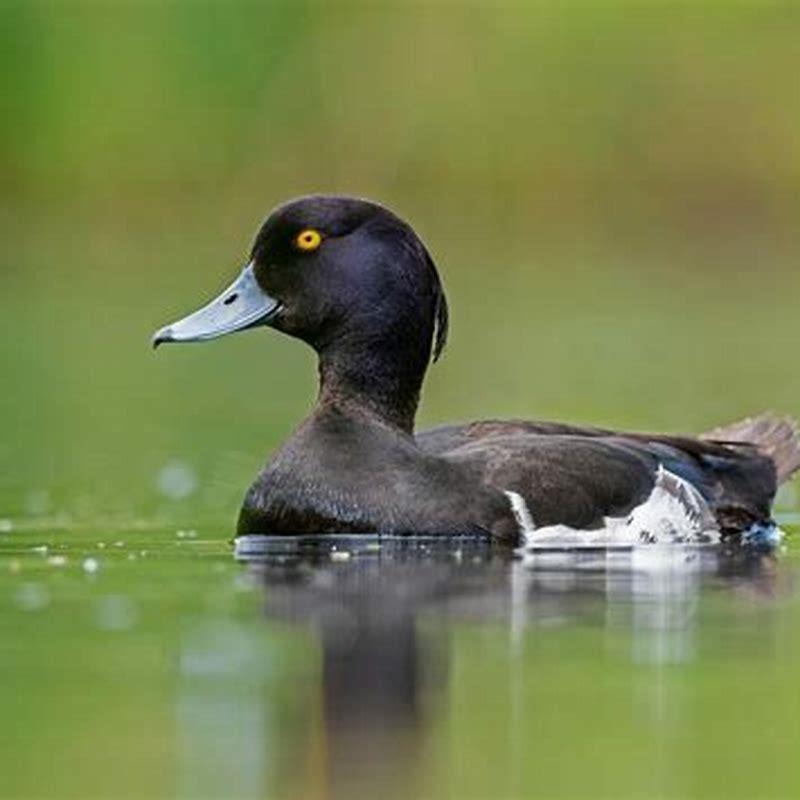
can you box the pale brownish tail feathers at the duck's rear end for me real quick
[700,413,800,484]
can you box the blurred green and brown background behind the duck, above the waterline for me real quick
[0,0,800,525]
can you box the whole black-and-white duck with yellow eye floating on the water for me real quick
[152,195,800,546]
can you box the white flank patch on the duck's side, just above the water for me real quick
[505,466,719,549]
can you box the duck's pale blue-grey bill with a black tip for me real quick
[153,263,280,347]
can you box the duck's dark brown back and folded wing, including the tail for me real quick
[417,415,800,534]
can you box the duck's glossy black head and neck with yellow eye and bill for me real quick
[153,196,447,427]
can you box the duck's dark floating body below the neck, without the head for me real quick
[238,406,793,543]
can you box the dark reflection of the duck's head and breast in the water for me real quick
[252,553,503,797]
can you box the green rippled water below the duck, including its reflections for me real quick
[0,528,800,798]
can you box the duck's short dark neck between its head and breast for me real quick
[318,346,427,435]
